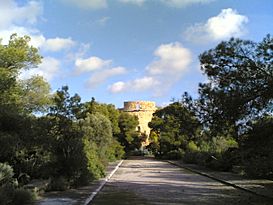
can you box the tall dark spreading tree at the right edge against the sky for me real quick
[199,35,273,138]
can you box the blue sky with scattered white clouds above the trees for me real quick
[0,0,273,107]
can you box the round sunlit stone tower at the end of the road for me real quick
[123,101,156,136]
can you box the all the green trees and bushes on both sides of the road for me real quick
[0,35,273,205]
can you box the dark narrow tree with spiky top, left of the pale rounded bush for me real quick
[44,86,86,184]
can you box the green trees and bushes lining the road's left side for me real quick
[0,35,140,205]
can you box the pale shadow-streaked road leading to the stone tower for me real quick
[92,158,271,205]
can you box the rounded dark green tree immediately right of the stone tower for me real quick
[149,102,200,158]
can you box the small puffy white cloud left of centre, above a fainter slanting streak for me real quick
[75,56,112,75]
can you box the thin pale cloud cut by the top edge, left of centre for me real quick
[62,0,107,9]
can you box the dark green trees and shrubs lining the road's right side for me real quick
[149,35,273,179]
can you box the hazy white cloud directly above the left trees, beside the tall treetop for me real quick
[20,57,60,81]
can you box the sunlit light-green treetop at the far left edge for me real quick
[0,34,41,109]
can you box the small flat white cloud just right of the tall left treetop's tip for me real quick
[42,37,76,51]
